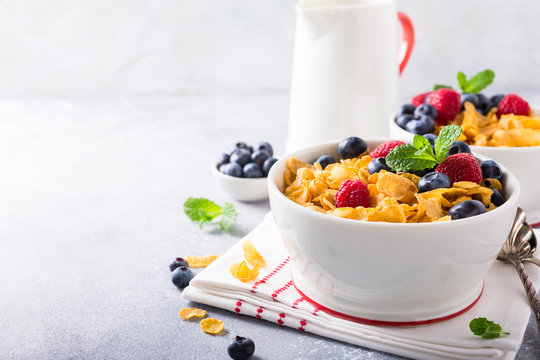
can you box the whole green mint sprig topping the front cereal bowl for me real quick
[386,125,463,171]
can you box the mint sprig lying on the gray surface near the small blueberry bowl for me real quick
[184,198,236,230]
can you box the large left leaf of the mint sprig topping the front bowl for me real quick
[386,143,437,171]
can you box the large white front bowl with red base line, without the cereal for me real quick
[268,139,519,326]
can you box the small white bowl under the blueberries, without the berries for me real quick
[212,166,268,202]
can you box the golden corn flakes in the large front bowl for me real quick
[284,155,502,223]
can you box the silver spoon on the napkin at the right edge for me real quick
[497,208,540,332]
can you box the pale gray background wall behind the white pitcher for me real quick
[0,0,540,96]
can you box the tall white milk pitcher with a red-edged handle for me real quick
[287,0,414,151]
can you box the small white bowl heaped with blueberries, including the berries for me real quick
[212,142,277,202]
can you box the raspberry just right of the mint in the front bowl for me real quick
[435,153,482,184]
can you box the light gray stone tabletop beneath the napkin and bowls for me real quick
[0,95,540,360]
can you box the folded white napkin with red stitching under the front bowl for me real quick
[182,213,540,360]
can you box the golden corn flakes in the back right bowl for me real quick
[448,102,540,147]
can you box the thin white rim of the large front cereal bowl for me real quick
[267,138,520,228]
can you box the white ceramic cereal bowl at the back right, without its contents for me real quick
[389,110,540,224]
